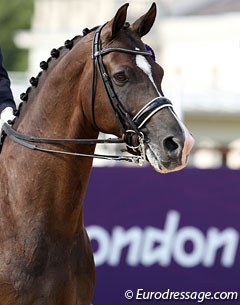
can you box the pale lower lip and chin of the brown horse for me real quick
[146,145,185,174]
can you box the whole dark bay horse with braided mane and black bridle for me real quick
[0,4,193,305]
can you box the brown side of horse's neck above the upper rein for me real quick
[17,43,98,138]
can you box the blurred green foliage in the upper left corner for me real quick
[0,0,34,71]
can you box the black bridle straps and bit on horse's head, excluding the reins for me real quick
[91,25,172,161]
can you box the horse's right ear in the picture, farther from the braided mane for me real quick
[131,2,157,37]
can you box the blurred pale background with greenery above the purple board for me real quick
[0,0,240,169]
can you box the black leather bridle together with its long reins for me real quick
[3,24,172,165]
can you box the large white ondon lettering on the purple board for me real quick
[87,211,239,268]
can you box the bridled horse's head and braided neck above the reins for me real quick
[4,3,193,173]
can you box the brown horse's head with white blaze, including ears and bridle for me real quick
[82,3,193,173]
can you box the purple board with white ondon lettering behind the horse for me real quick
[85,168,240,305]
